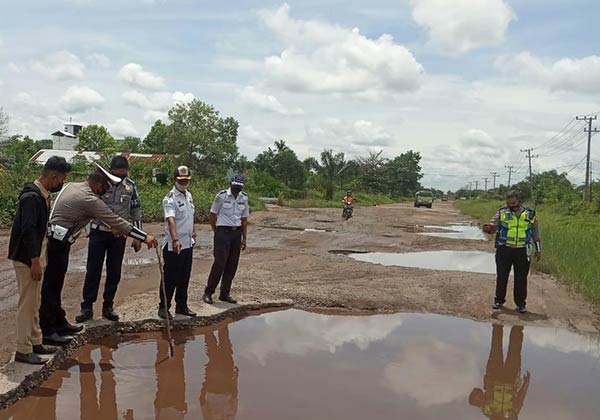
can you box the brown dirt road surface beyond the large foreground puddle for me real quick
[0,203,600,364]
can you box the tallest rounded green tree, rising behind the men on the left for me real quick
[167,99,239,176]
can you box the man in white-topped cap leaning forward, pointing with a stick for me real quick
[40,165,157,345]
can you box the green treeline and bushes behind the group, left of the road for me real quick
[0,100,423,228]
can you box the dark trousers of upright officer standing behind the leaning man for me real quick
[81,229,127,309]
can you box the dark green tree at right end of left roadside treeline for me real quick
[386,150,423,197]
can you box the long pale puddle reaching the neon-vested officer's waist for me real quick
[349,251,496,274]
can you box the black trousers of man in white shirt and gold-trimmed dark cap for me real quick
[159,245,193,309]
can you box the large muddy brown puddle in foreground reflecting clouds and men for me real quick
[0,310,600,420]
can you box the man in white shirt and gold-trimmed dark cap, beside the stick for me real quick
[158,166,196,319]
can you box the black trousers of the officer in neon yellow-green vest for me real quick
[496,246,530,306]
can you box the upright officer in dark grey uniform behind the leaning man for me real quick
[75,156,142,322]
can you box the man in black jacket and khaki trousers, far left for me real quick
[8,156,71,365]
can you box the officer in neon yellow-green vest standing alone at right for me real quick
[483,191,542,313]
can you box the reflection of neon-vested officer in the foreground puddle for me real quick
[469,325,531,420]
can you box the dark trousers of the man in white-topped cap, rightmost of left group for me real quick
[204,227,242,297]
